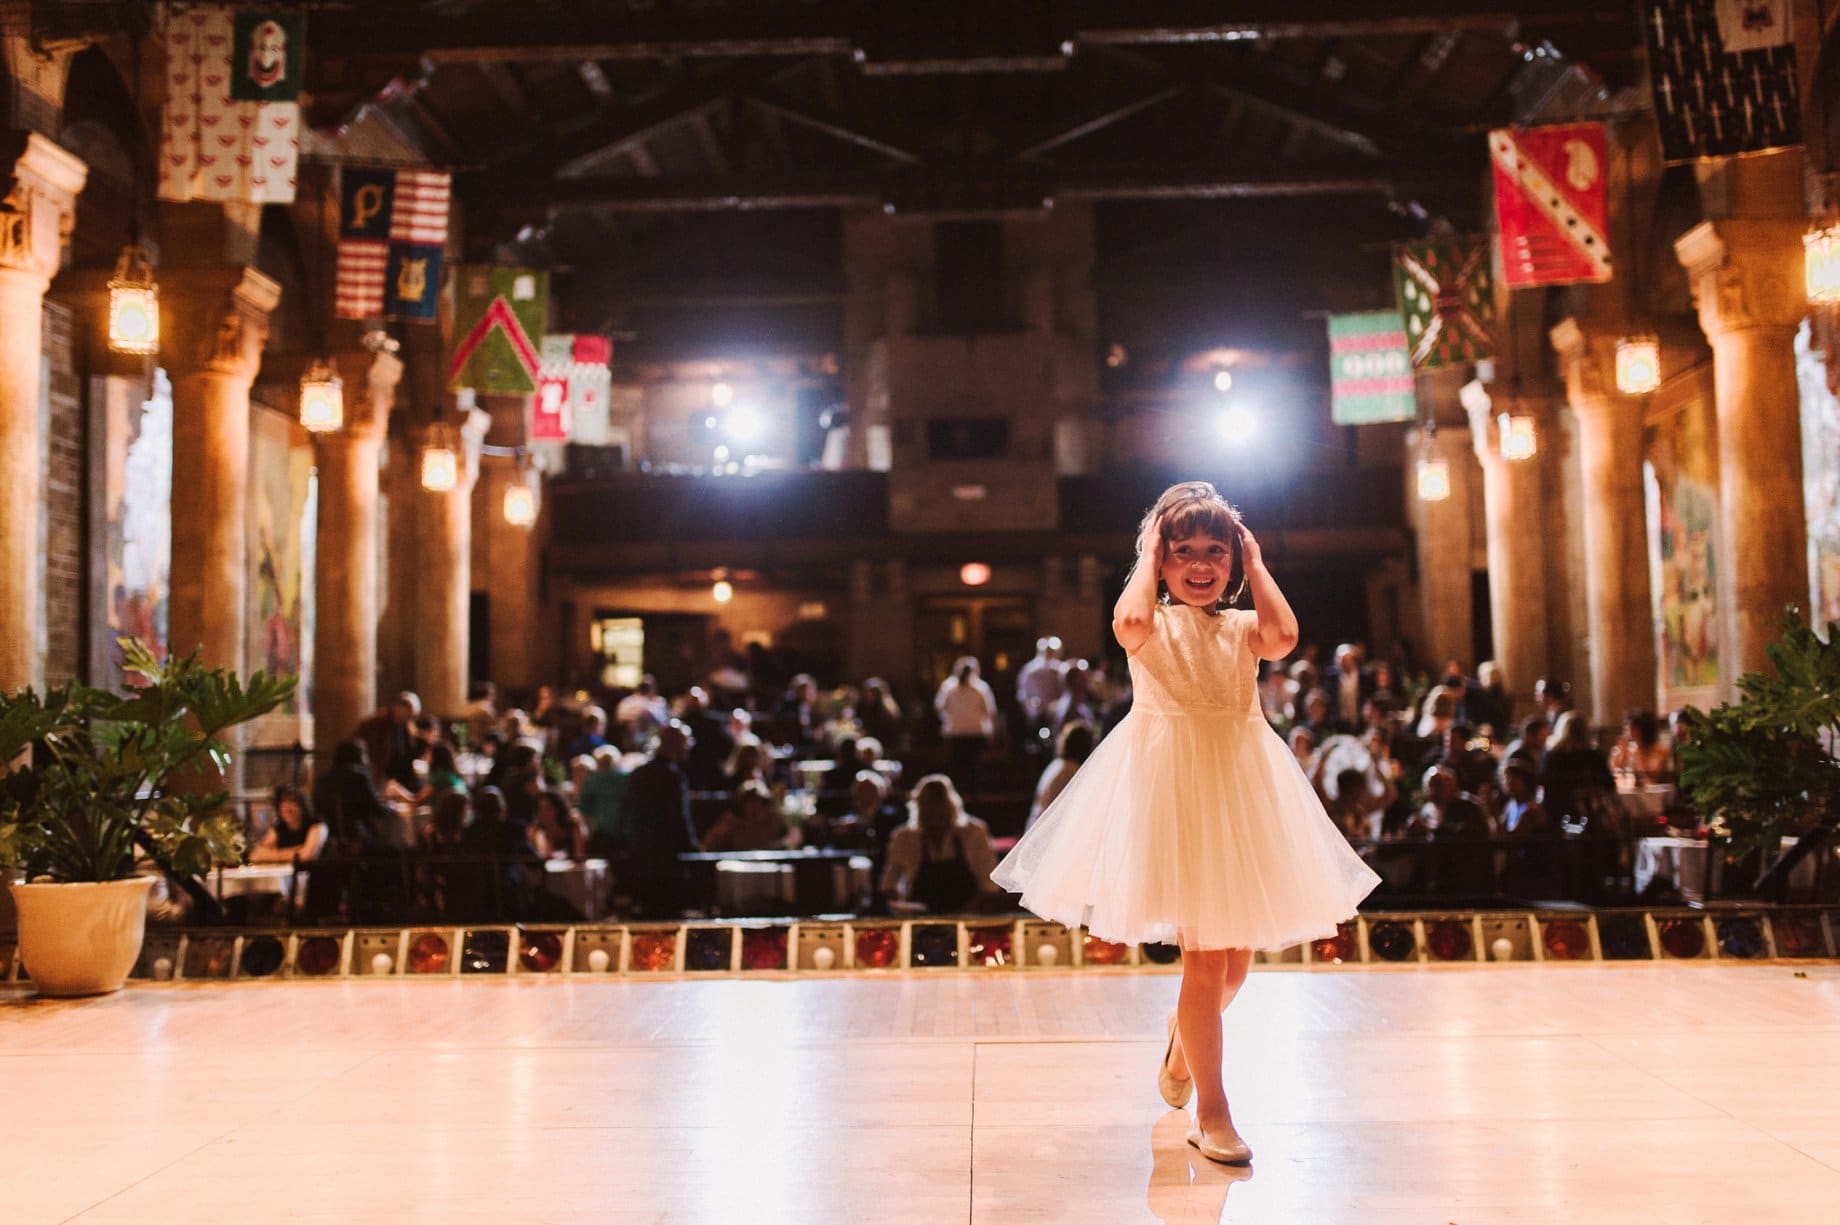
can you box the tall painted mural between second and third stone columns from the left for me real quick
[247,406,318,745]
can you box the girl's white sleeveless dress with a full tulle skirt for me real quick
[992,603,1380,949]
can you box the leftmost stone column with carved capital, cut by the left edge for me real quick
[0,132,88,693]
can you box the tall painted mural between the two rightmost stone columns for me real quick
[1643,370,1719,710]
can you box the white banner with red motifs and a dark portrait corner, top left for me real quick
[158,6,305,204]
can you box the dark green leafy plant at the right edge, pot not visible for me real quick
[1676,609,1840,887]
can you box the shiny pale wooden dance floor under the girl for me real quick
[0,964,1840,1225]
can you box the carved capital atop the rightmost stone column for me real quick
[1674,217,1809,338]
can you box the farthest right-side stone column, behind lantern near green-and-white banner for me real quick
[1406,370,1476,668]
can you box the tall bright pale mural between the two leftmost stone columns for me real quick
[104,370,173,690]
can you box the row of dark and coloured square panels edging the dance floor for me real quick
[0,907,1840,982]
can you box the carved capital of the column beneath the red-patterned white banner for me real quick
[160,267,282,381]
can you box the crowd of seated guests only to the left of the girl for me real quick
[261,673,1015,922]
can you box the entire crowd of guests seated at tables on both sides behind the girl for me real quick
[250,638,1673,922]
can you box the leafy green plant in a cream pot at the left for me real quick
[0,638,294,995]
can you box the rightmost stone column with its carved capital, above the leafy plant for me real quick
[1674,217,1809,692]
